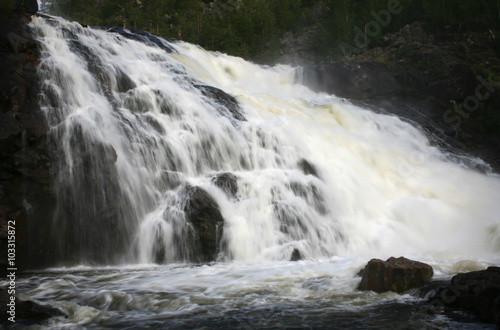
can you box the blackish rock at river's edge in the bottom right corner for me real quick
[429,267,500,328]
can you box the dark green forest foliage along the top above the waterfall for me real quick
[43,0,500,60]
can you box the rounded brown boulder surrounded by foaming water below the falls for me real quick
[358,257,434,293]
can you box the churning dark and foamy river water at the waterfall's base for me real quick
[14,257,494,329]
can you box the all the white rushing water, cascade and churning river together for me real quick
[3,14,500,328]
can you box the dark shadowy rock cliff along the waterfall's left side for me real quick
[0,0,53,270]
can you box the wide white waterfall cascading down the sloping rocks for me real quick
[31,17,500,264]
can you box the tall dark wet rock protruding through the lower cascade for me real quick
[181,185,224,262]
